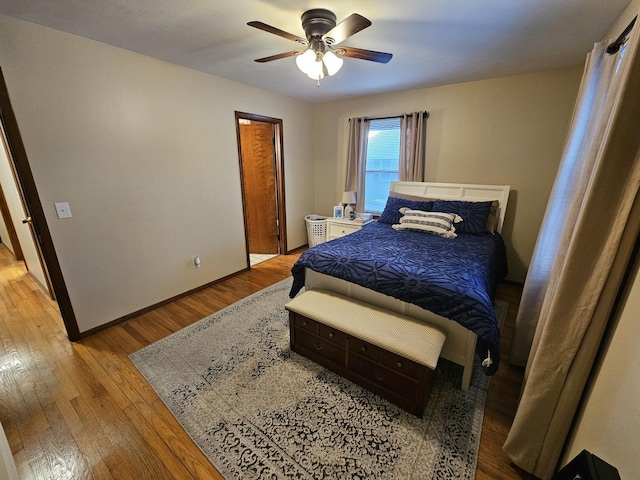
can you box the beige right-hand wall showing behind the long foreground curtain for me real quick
[562,0,640,478]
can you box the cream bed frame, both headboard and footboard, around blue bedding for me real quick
[305,182,510,390]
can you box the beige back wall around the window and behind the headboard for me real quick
[315,69,586,281]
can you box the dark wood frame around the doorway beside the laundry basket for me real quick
[235,111,289,265]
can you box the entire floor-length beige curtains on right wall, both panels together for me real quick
[504,18,640,479]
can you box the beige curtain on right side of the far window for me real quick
[398,112,429,182]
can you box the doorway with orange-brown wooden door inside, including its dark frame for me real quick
[235,112,287,267]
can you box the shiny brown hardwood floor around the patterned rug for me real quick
[0,245,532,480]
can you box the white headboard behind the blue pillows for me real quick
[390,182,511,232]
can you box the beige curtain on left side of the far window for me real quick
[344,118,369,212]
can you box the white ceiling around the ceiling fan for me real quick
[0,0,630,103]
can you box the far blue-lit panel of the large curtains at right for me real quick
[509,31,632,366]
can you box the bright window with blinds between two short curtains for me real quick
[364,117,400,213]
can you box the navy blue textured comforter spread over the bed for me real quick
[290,222,507,375]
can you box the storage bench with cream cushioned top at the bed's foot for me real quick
[285,290,446,417]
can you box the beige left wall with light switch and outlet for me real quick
[0,17,314,332]
